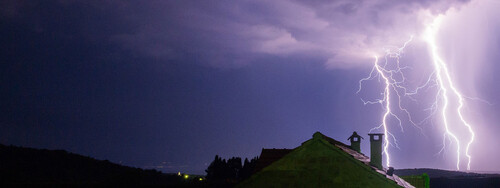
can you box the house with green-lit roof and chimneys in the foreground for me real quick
[237,132,413,187]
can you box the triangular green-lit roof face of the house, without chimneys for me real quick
[237,133,400,187]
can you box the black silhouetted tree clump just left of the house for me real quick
[205,155,259,183]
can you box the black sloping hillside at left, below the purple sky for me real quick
[0,144,203,187]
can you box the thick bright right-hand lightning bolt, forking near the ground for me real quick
[425,17,475,170]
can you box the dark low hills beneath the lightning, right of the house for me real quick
[394,168,500,188]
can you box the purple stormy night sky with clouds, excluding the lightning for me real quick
[0,0,500,174]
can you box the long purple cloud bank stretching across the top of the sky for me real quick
[3,0,464,67]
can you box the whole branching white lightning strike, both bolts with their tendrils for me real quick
[356,17,475,170]
